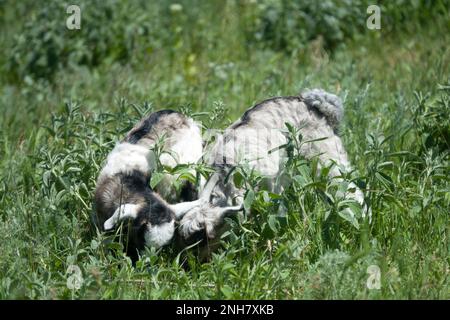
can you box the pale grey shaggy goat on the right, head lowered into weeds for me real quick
[177,89,364,251]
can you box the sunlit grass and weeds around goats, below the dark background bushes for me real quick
[0,0,450,299]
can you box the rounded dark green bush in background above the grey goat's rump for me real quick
[251,0,367,52]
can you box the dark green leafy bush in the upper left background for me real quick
[8,0,167,79]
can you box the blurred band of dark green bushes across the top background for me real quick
[6,0,449,80]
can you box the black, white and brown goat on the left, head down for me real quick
[95,110,203,260]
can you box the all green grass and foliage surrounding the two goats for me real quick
[0,0,450,299]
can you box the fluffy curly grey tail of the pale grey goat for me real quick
[300,89,344,129]
